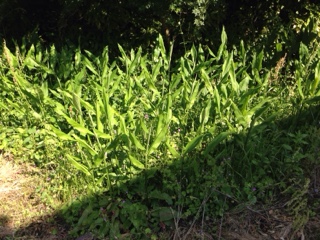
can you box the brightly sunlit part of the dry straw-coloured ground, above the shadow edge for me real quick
[0,155,56,237]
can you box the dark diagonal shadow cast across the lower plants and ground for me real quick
[0,105,320,240]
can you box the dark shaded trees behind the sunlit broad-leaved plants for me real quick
[0,0,319,55]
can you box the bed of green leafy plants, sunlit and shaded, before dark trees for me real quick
[0,16,320,239]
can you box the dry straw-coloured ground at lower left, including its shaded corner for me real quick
[0,154,66,240]
